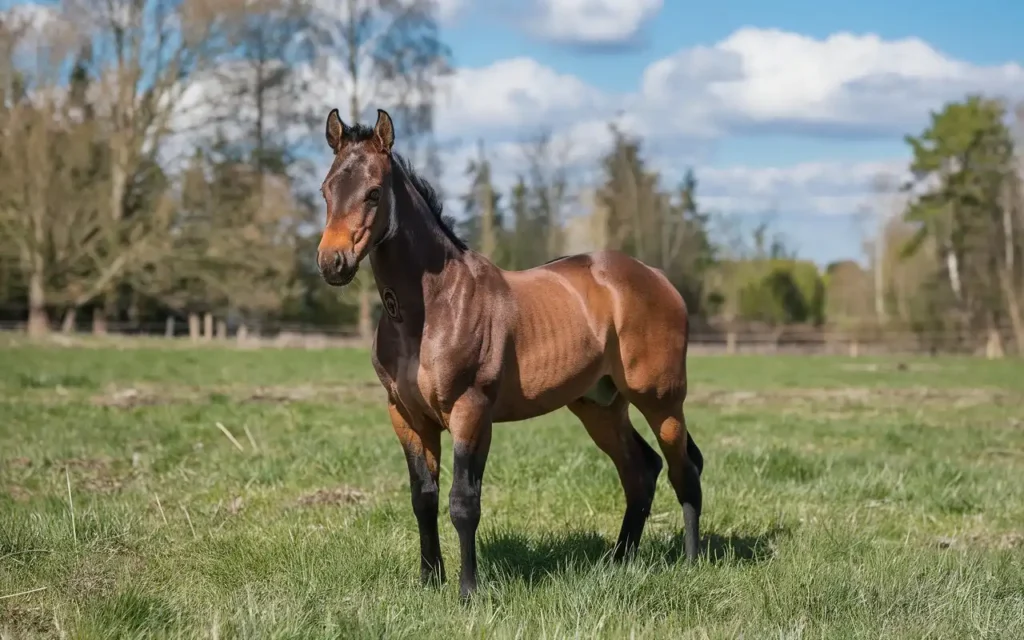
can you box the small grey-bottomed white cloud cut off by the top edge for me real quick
[529,0,664,45]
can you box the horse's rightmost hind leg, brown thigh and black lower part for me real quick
[634,398,703,561]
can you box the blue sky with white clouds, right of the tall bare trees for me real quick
[425,0,1024,264]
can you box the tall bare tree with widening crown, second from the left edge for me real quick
[63,0,232,333]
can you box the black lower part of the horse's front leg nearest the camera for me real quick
[449,442,486,598]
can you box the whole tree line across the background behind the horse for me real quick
[0,0,1024,352]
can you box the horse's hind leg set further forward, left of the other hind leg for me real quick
[568,396,662,560]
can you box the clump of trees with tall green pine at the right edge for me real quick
[826,94,1024,356]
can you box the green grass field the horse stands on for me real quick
[0,345,1024,638]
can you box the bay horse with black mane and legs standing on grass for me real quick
[316,110,703,599]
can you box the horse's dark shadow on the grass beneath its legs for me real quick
[479,525,790,584]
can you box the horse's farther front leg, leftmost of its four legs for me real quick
[388,402,444,585]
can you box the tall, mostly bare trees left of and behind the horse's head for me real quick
[0,0,451,334]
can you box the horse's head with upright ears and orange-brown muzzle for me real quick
[316,109,394,287]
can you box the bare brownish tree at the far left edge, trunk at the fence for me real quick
[0,8,120,334]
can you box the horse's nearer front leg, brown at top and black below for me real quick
[449,391,492,599]
